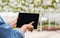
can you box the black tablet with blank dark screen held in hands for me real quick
[17,13,39,29]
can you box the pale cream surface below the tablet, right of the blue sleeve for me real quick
[25,30,60,38]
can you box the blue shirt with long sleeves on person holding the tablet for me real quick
[0,17,24,38]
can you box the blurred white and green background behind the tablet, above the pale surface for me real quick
[0,0,60,30]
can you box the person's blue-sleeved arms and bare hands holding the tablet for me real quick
[0,18,33,38]
